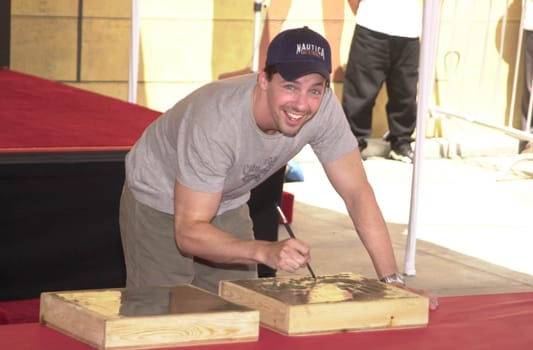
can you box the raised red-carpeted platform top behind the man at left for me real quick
[0,69,160,154]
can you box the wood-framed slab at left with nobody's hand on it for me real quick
[40,285,259,349]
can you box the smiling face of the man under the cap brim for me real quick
[263,73,326,136]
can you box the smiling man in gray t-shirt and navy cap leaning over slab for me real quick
[120,27,403,293]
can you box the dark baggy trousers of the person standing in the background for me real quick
[342,25,420,148]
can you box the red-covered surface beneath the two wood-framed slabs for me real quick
[0,293,533,350]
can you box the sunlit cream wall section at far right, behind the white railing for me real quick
[427,0,523,149]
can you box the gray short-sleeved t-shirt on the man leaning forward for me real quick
[126,74,357,215]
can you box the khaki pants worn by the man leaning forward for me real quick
[120,186,257,294]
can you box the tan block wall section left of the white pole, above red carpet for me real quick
[10,0,131,100]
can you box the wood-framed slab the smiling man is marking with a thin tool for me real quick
[219,273,429,335]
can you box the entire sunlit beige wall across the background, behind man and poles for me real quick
[10,0,521,153]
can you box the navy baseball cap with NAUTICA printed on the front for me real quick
[266,26,331,82]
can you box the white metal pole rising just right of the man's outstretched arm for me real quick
[404,0,439,276]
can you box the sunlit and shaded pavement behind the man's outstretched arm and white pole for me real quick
[280,141,533,296]
